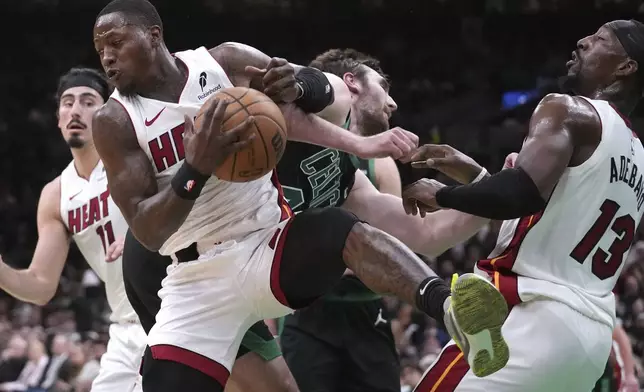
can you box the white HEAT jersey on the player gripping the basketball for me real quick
[111,47,288,255]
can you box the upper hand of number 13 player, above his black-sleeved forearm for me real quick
[411,144,483,184]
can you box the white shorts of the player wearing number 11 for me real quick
[91,324,145,392]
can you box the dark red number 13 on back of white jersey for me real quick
[570,199,635,280]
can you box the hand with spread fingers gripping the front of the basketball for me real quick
[183,99,255,175]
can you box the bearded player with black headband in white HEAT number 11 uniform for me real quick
[0,68,145,392]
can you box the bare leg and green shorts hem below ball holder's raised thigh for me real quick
[226,321,299,392]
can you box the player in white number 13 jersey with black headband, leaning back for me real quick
[403,20,644,392]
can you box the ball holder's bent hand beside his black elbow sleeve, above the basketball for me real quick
[246,57,298,103]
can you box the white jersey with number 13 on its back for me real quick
[477,99,644,327]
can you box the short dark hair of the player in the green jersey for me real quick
[309,49,387,79]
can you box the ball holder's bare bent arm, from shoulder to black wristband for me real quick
[92,101,194,251]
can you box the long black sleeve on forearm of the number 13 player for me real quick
[436,168,546,220]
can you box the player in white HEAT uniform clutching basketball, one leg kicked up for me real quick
[93,0,508,392]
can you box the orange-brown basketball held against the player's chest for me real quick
[195,87,287,182]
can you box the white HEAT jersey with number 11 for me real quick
[60,161,138,322]
